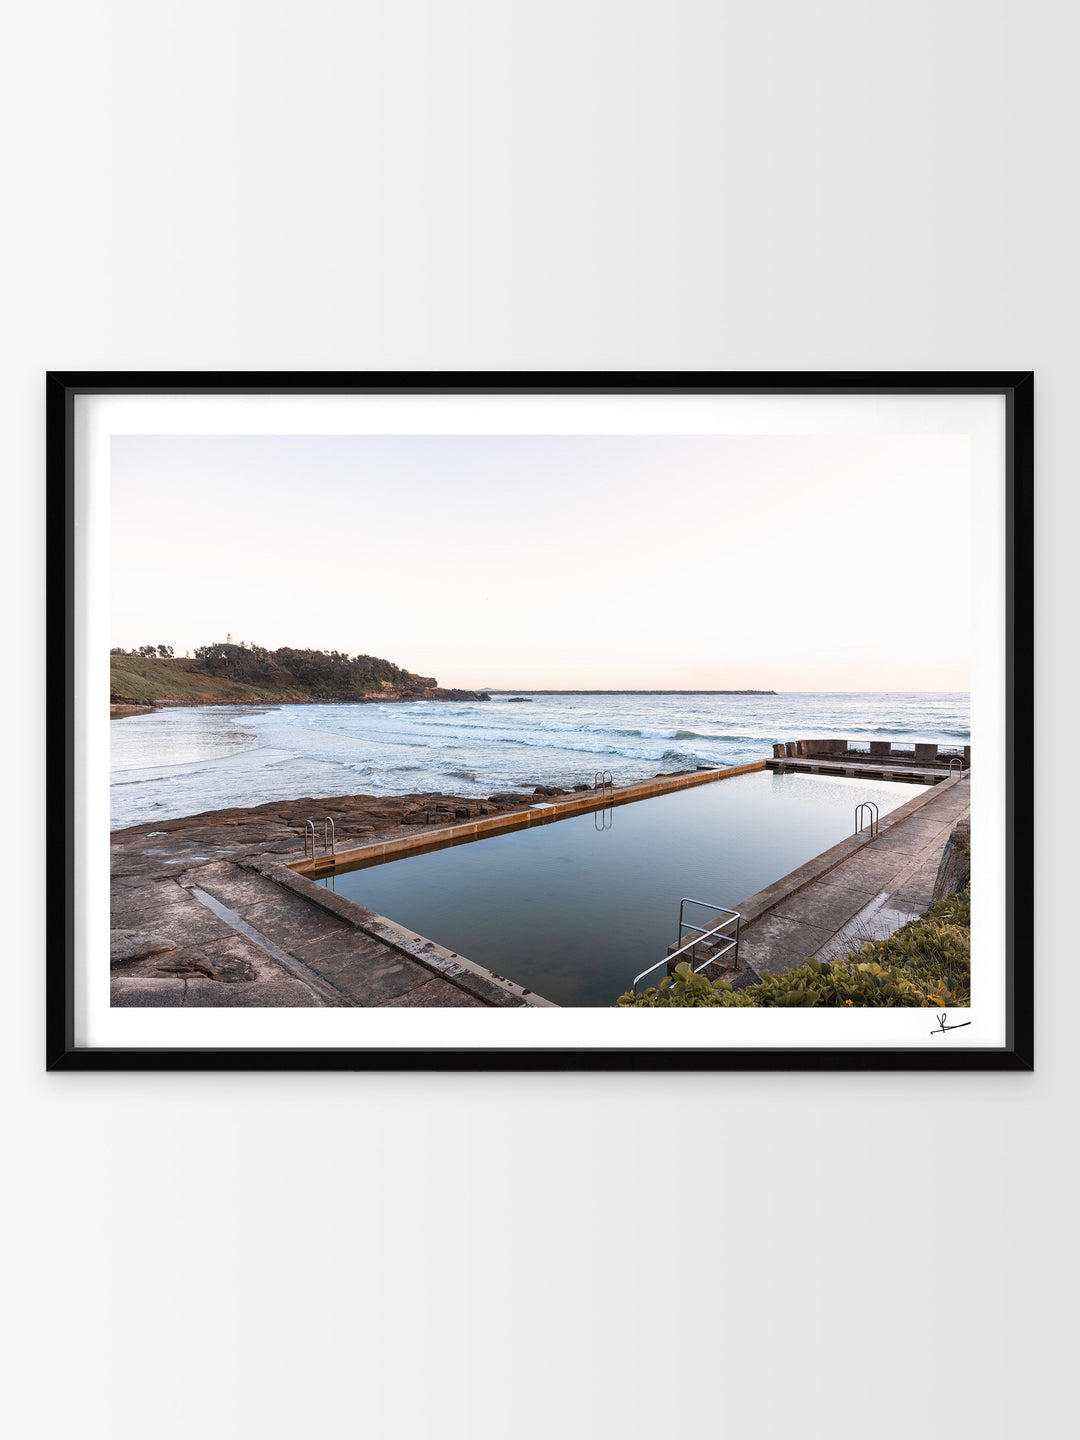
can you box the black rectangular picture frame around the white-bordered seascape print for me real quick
[46,370,1034,1071]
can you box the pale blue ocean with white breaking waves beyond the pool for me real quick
[111,691,971,829]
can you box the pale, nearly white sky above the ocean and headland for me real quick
[111,435,971,690]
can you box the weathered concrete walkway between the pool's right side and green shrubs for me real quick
[737,778,971,975]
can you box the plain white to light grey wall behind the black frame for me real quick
[0,8,1080,1440]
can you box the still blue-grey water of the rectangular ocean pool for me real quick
[325,770,926,1005]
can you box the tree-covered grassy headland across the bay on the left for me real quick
[109,641,485,704]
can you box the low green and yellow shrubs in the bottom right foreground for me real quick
[616,890,971,1008]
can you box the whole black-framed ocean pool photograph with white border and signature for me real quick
[48,372,1032,1070]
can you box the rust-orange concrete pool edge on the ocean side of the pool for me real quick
[282,760,771,875]
